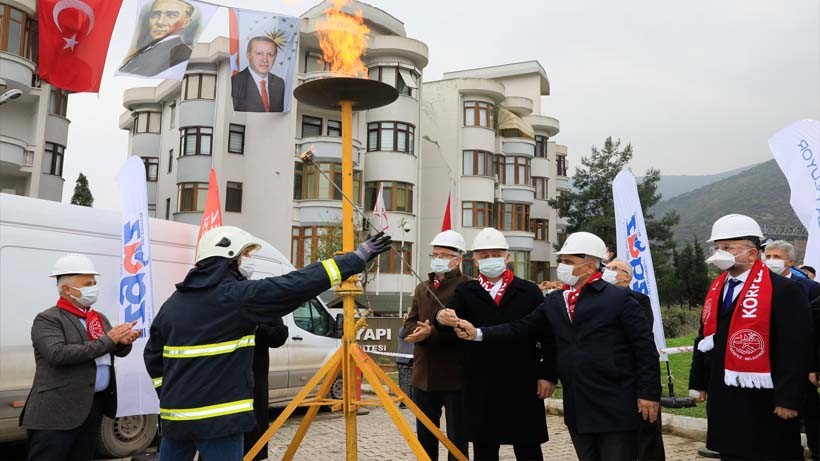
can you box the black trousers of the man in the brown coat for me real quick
[413,387,469,461]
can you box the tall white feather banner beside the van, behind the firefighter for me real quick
[115,156,159,416]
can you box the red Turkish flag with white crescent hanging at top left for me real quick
[37,0,122,93]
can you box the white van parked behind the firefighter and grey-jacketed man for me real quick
[0,194,341,457]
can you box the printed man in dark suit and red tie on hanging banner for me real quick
[231,35,285,112]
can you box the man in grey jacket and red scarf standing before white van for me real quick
[20,253,139,460]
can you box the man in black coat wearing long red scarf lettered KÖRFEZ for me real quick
[689,214,811,460]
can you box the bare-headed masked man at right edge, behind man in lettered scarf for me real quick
[764,240,820,459]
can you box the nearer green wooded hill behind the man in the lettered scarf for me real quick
[651,160,800,242]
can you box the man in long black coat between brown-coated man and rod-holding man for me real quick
[434,228,556,460]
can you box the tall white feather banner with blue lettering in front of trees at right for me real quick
[612,170,668,361]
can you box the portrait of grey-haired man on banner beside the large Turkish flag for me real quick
[119,0,199,77]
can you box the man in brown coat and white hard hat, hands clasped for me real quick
[404,230,470,461]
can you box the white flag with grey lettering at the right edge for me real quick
[769,120,820,267]
